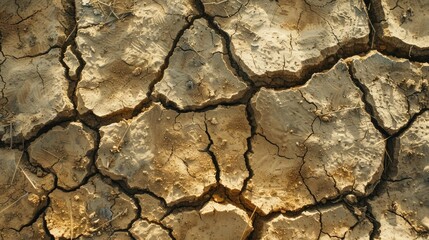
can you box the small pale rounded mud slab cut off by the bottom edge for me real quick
[130,219,172,240]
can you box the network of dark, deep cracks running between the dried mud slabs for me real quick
[0,0,428,239]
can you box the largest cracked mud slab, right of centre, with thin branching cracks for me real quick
[247,62,385,214]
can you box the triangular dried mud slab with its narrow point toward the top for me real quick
[154,19,246,109]
